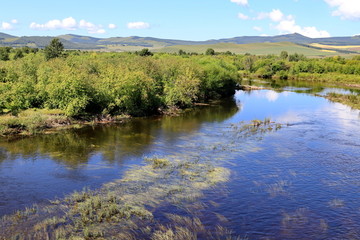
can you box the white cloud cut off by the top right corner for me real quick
[324,0,360,20]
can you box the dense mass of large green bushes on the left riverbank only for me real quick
[0,52,242,117]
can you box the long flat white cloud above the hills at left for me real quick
[30,17,106,34]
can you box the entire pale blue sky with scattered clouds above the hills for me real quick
[0,0,360,41]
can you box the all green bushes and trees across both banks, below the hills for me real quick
[0,47,360,117]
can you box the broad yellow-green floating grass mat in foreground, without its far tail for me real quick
[0,157,230,239]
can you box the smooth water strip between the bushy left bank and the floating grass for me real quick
[0,98,239,216]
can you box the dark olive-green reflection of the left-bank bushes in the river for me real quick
[0,99,238,168]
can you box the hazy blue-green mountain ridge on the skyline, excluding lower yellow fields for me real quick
[0,32,360,50]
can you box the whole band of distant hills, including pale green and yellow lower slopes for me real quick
[0,33,360,55]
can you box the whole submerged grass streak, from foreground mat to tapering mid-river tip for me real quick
[0,119,283,240]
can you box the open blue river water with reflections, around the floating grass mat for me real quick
[0,81,360,239]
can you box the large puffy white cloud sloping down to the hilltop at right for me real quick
[256,9,330,38]
